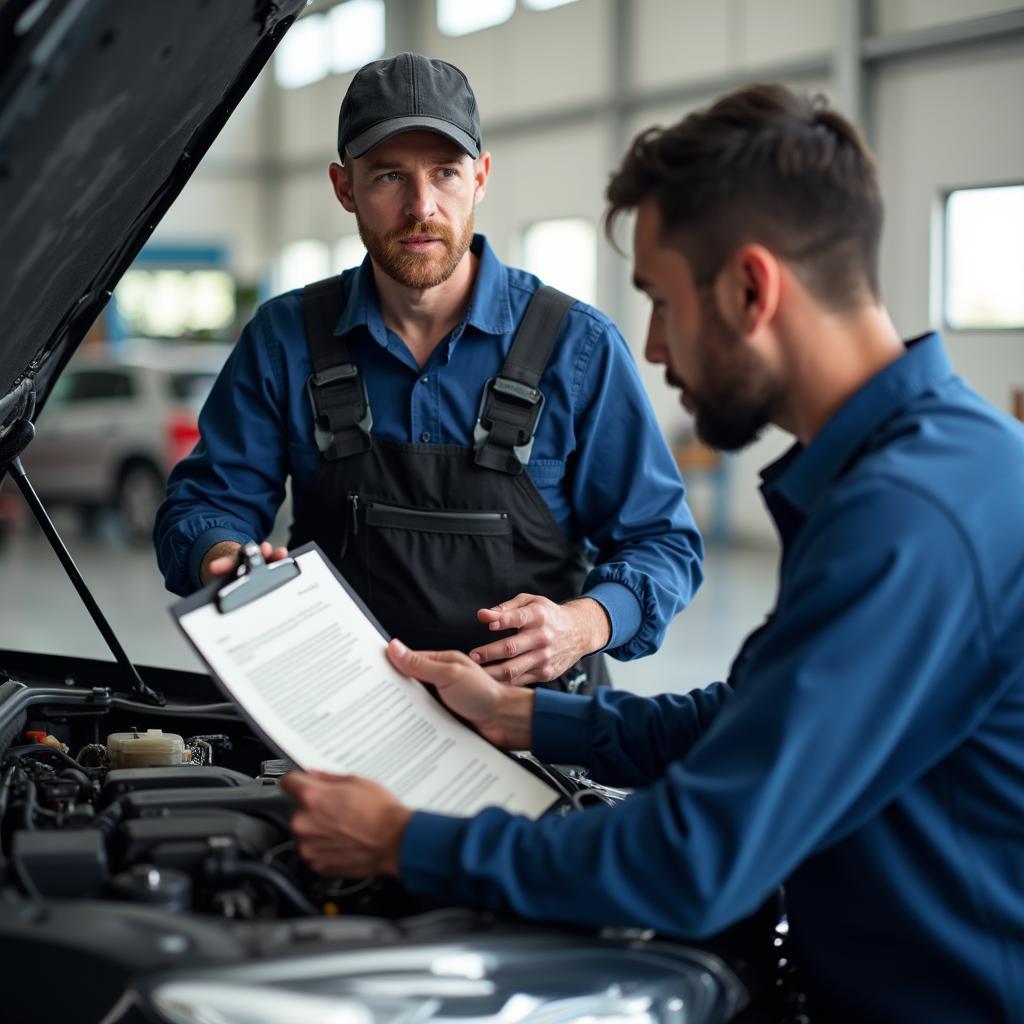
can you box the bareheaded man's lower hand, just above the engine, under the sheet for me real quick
[281,771,413,879]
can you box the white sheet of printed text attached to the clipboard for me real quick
[172,545,556,817]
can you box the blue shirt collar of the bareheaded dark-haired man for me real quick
[761,332,953,515]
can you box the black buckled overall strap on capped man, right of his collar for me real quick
[473,285,575,476]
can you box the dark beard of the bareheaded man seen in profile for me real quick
[686,294,782,452]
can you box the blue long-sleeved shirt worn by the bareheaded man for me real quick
[401,335,1024,1024]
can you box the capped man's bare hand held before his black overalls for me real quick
[469,594,611,686]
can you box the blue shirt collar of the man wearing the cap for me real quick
[334,234,513,348]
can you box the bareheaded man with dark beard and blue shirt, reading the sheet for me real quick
[285,86,1024,1024]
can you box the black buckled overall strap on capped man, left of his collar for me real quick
[302,276,374,460]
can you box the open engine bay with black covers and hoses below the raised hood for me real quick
[0,663,448,921]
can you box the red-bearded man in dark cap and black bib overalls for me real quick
[155,53,702,691]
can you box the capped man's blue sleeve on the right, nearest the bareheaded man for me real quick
[571,322,703,660]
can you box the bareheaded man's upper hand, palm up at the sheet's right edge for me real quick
[387,640,535,751]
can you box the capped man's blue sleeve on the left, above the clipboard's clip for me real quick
[154,310,289,594]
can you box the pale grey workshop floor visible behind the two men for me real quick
[0,519,775,693]
